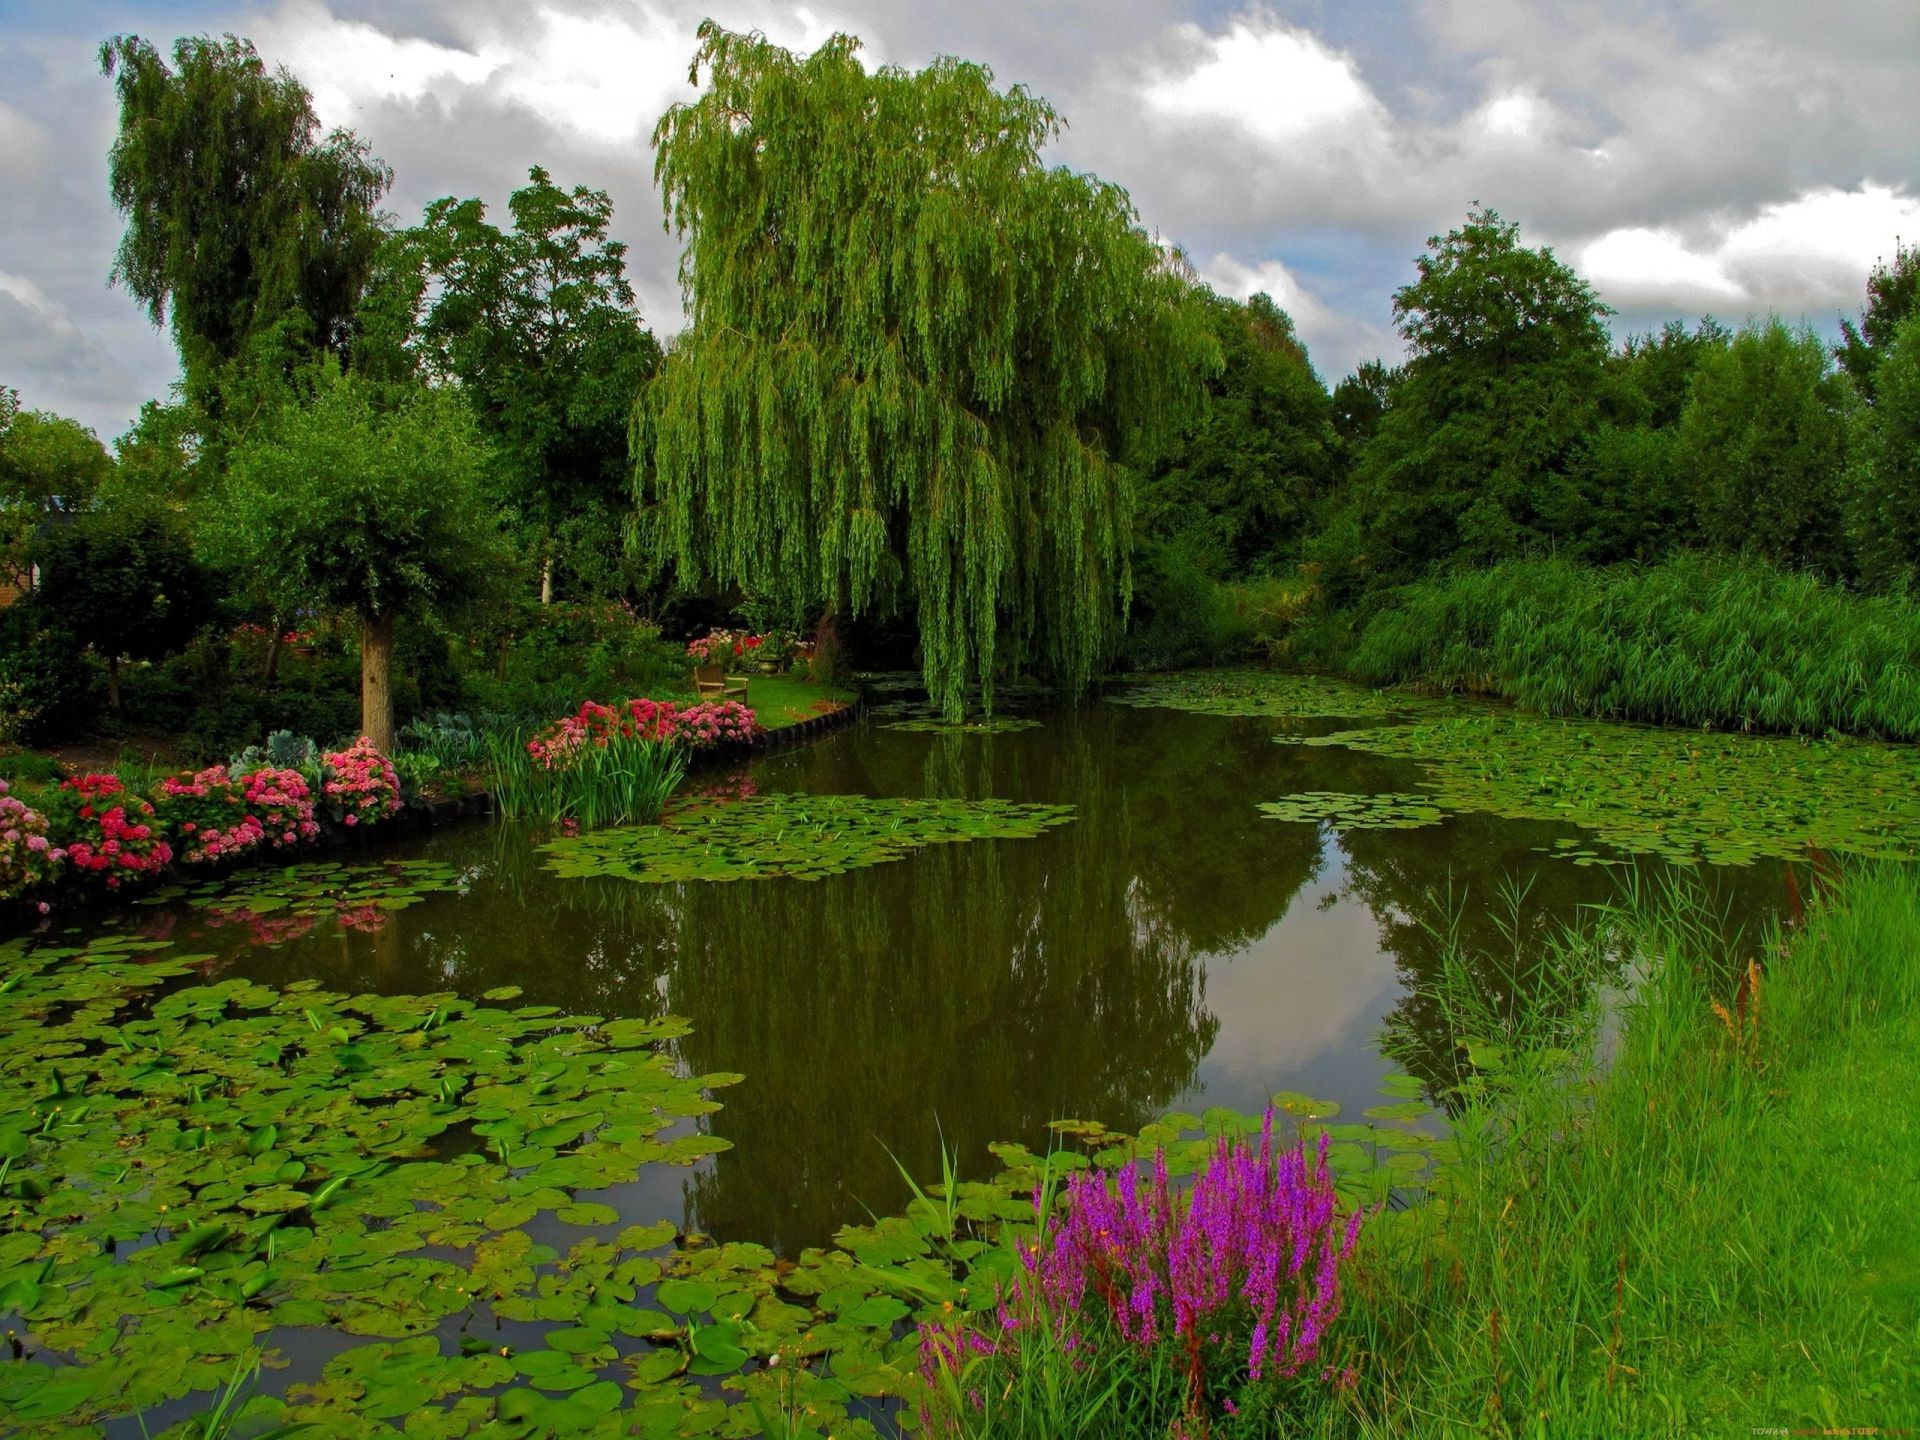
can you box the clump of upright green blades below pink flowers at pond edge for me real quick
[484,730,687,826]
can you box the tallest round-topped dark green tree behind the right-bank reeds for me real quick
[1350,209,1611,576]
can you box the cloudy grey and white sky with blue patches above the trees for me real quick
[0,0,1920,440]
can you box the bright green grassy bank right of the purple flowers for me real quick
[1325,870,1920,1436]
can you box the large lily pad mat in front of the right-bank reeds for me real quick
[1275,710,1920,864]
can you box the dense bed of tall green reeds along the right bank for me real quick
[1332,555,1920,739]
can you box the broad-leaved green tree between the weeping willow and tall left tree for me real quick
[407,167,660,601]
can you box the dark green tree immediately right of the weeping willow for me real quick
[1139,296,1336,574]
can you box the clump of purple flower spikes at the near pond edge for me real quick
[920,1110,1363,1438]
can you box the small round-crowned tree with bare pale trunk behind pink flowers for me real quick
[217,372,505,751]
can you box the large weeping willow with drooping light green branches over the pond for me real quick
[636,21,1219,716]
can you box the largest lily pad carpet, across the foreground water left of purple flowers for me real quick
[0,937,1444,1438]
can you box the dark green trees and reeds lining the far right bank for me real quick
[1125,209,1920,737]
